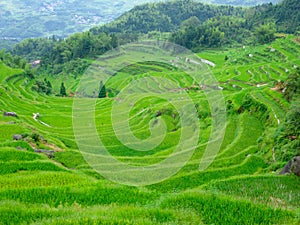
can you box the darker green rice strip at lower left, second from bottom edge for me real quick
[0,183,158,207]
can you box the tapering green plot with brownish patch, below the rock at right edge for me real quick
[203,175,300,210]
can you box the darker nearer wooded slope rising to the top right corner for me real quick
[171,0,300,51]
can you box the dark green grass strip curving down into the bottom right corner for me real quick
[163,191,296,224]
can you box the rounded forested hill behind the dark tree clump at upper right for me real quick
[92,0,300,33]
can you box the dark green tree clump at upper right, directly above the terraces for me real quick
[170,16,275,51]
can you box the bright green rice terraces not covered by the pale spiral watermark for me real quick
[0,36,300,225]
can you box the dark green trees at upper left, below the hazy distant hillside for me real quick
[13,31,119,65]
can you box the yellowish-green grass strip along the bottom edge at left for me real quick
[0,201,203,225]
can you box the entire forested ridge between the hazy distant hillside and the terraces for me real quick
[14,0,300,65]
